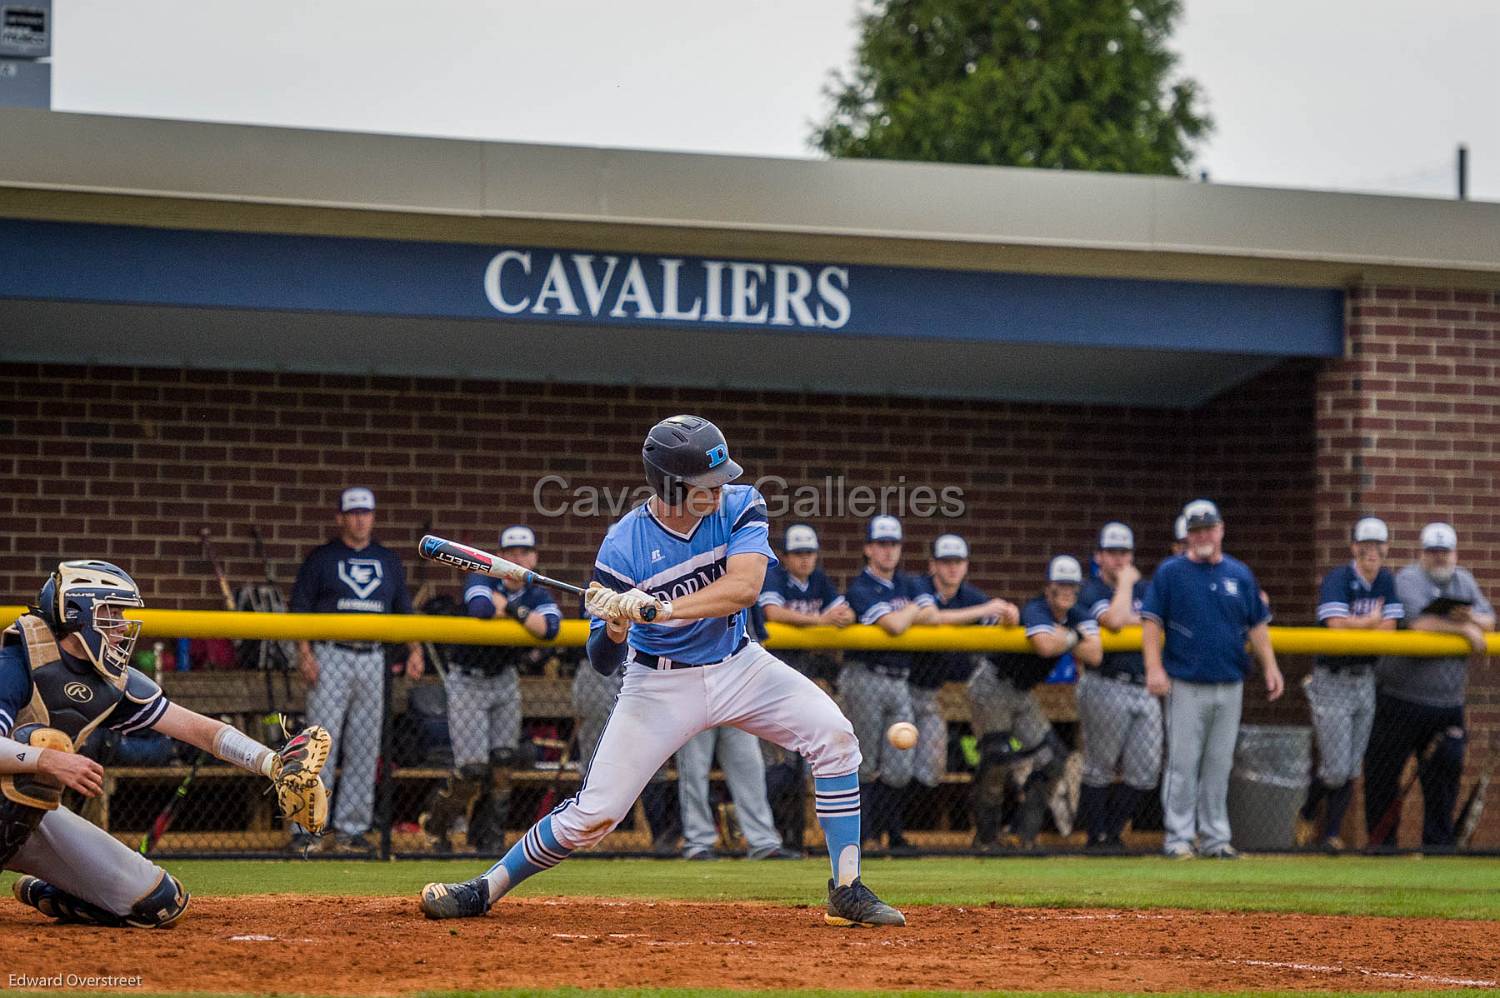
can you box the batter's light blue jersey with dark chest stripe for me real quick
[590,485,776,662]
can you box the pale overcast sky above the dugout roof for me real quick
[53,0,1500,200]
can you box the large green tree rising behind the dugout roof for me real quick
[812,0,1212,176]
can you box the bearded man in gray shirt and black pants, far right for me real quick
[1365,522,1496,849]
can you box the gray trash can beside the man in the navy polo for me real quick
[1229,725,1313,852]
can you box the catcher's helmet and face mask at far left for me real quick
[36,561,146,684]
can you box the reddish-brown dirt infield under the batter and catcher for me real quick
[0,894,1500,995]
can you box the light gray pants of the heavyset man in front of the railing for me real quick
[1161,678,1245,854]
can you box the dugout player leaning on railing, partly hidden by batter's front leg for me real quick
[758,524,854,849]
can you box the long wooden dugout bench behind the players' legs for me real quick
[93,671,1077,852]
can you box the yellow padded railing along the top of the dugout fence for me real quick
[0,606,1482,657]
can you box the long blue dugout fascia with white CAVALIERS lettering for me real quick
[0,219,1343,356]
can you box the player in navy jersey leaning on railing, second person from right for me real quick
[1298,516,1406,852]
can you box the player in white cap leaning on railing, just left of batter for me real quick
[422,524,563,852]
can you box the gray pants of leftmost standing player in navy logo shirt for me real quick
[308,641,386,836]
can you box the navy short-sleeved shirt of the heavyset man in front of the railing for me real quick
[1140,555,1271,683]
